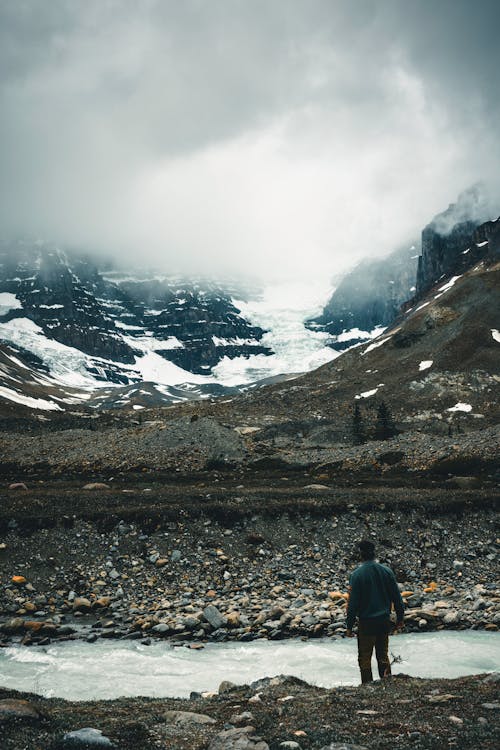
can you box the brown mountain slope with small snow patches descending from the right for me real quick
[193,219,500,452]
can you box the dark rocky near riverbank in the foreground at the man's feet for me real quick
[0,674,500,750]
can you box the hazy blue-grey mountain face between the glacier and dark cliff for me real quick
[308,243,418,349]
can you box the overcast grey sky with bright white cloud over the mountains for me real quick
[0,0,500,278]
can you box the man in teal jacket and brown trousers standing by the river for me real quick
[346,540,404,683]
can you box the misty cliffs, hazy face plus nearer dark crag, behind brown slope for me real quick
[309,183,495,349]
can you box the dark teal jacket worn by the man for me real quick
[346,560,404,630]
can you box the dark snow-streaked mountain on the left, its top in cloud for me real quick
[0,242,272,394]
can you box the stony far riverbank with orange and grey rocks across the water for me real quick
[0,476,500,648]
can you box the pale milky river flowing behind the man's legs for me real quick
[0,631,500,700]
